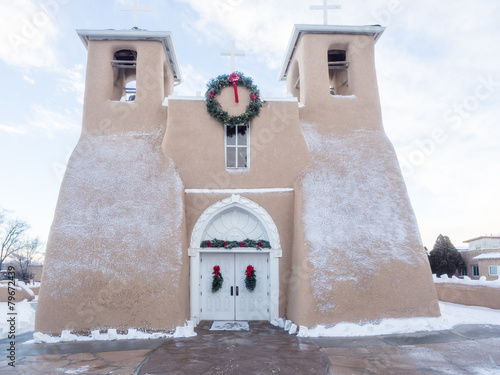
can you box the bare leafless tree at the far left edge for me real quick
[0,211,29,269]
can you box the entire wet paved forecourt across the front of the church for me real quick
[0,322,500,375]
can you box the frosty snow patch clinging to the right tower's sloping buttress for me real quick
[302,123,425,312]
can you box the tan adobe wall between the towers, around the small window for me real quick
[162,95,309,189]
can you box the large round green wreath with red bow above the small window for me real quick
[205,72,262,125]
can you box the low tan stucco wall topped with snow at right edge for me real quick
[435,284,500,309]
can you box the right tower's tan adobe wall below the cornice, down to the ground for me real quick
[287,34,440,327]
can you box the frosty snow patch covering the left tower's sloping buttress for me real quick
[45,129,184,295]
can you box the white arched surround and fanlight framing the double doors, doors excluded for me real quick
[189,194,282,322]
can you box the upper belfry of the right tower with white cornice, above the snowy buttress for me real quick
[279,25,385,130]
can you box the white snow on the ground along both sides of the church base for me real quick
[0,301,500,343]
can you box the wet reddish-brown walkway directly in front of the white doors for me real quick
[139,322,327,375]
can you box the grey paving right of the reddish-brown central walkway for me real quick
[314,325,500,375]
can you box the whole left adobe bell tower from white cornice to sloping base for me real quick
[35,29,189,334]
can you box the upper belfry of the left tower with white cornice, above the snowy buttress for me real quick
[77,29,181,134]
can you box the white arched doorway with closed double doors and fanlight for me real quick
[189,195,281,322]
